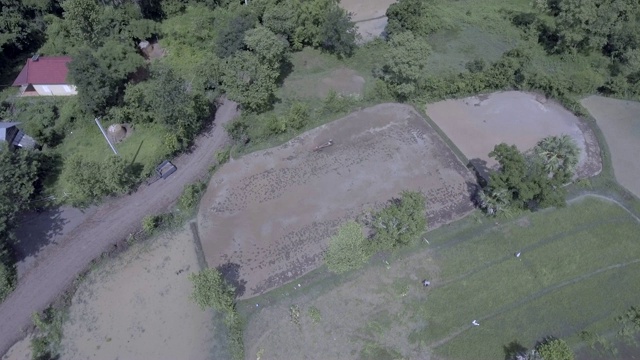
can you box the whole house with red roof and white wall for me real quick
[13,55,78,96]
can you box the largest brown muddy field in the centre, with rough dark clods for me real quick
[198,104,475,298]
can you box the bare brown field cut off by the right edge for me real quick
[582,96,640,198]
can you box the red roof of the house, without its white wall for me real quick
[13,56,71,86]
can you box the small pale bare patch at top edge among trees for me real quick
[340,0,396,42]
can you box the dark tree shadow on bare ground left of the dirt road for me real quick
[9,207,69,262]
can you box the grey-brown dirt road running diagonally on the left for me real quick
[0,100,236,354]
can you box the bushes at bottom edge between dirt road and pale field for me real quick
[31,307,66,360]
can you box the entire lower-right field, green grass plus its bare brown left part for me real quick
[240,197,640,360]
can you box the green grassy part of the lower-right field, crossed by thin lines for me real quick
[420,199,640,359]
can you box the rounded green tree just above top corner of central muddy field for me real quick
[379,31,431,99]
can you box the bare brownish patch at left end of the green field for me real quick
[245,250,440,360]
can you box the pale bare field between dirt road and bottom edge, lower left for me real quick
[61,225,214,359]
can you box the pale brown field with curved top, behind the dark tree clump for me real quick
[426,91,602,178]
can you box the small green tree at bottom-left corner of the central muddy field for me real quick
[189,268,235,314]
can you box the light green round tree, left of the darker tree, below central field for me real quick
[325,221,369,274]
